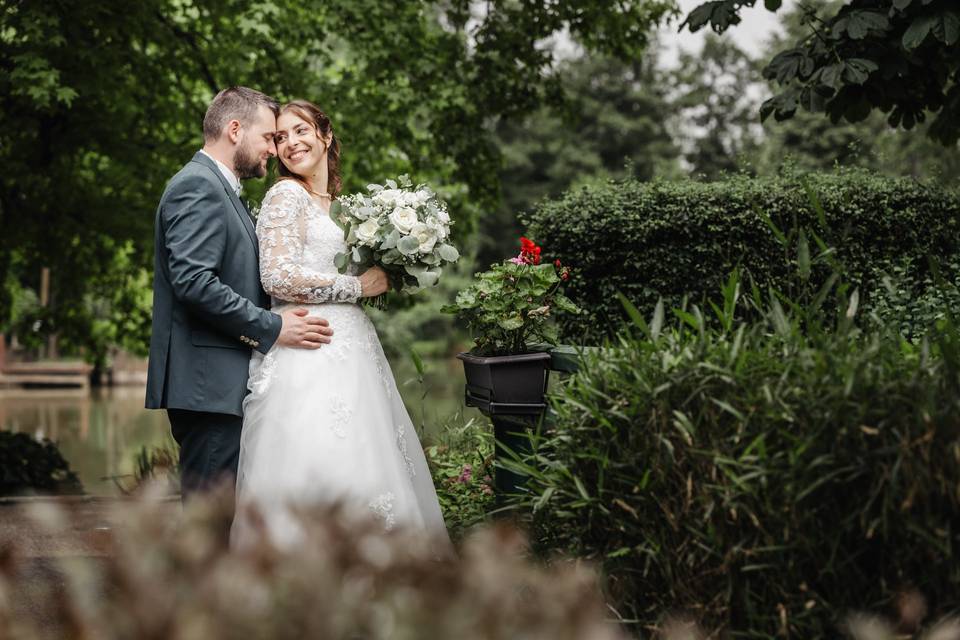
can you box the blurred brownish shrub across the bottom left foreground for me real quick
[0,490,623,640]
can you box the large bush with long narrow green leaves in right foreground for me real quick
[518,288,960,638]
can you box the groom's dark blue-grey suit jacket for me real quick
[146,152,281,416]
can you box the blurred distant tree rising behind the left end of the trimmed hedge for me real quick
[479,52,679,266]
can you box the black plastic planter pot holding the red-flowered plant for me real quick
[457,352,550,416]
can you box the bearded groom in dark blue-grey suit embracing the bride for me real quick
[146,87,333,499]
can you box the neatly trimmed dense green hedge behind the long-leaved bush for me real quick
[524,171,960,341]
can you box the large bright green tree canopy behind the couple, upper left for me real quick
[0,0,673,359]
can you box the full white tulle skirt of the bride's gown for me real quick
[232,303,449,545]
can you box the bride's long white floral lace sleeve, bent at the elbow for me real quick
[257,181,361,303]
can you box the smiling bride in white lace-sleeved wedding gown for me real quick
[233,100,449,544]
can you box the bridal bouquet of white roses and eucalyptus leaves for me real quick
[330,176,460,305]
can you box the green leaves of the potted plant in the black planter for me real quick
[442,242,580,355]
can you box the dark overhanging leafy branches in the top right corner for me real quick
[681,0,960,145]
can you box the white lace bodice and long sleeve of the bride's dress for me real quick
[257,180,361,303]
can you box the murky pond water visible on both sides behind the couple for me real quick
[0,359,482,495]
